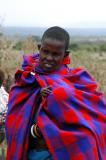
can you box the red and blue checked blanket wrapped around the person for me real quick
[6,55,106,160]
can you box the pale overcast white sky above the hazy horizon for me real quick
[0,0,106,28]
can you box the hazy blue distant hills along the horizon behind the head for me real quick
[2,27,106,37]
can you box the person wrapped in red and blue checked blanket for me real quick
[6,26,106,160]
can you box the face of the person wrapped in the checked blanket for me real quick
[40,38,65,73]
